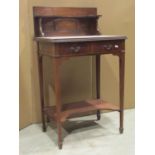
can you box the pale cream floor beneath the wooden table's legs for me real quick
[19,110,134,155]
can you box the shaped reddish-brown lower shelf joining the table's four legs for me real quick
[44,99,120,122]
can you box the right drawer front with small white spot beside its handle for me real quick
[92,41,124,53]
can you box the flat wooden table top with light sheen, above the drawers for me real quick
[34,35,127,43]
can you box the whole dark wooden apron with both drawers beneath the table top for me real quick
[39,40,125,57]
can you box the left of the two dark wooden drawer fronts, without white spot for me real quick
[56,43,90,56]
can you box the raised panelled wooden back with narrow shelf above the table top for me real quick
[33,7,99,36]
